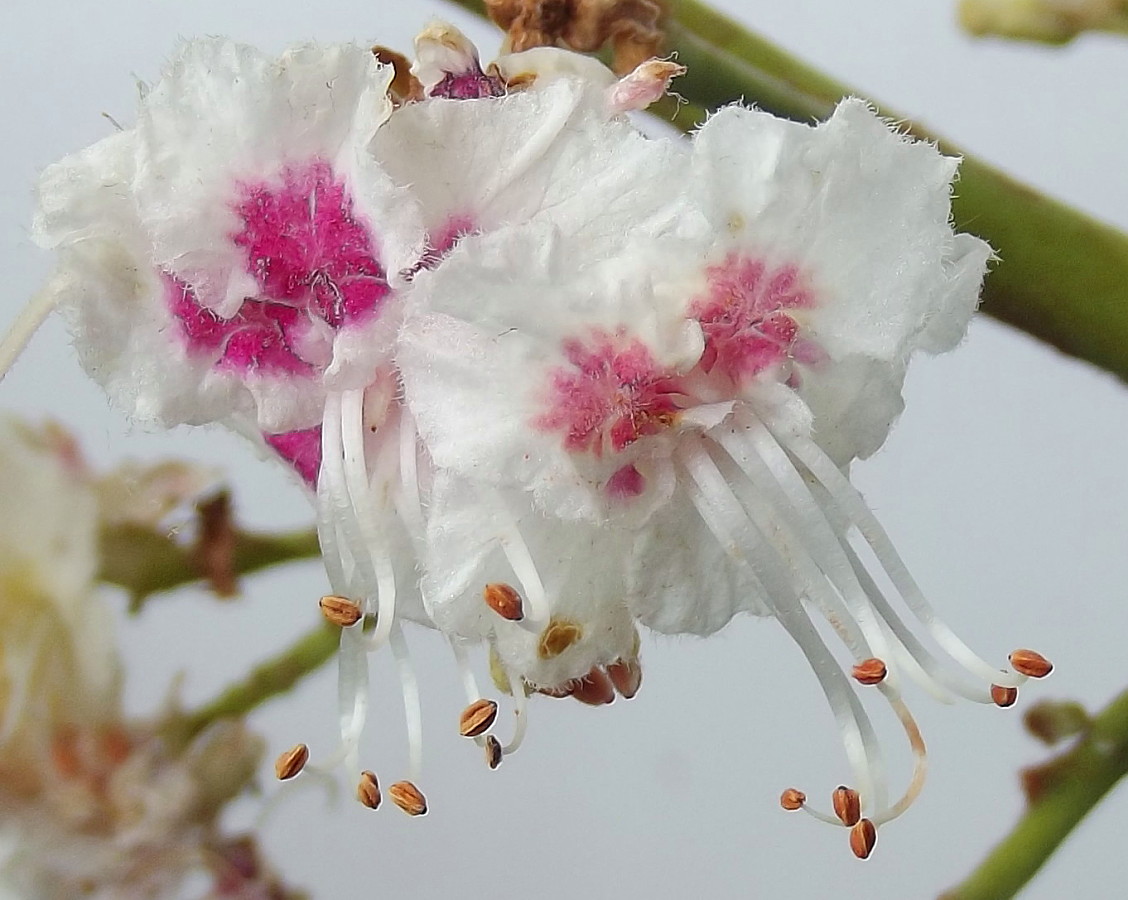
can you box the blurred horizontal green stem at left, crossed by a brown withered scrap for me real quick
[98,524,320,610]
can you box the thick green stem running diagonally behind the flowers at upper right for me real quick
[452,0,1128,379]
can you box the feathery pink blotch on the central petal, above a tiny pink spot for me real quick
[536,329,680,457]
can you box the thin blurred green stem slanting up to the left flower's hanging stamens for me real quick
[168,625,341,747]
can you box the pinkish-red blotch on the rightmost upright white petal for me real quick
[690,253,820,381]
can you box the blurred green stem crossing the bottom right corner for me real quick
[941,691,1128,900]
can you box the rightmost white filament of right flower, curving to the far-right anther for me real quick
[775,434,1025,687]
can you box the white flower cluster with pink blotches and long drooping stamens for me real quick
[24,24,1045,855]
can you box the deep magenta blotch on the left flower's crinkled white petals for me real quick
[166,159,390,374]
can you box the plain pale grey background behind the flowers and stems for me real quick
[0,0,1128,900]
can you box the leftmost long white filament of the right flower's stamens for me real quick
[677,442,885,821]
